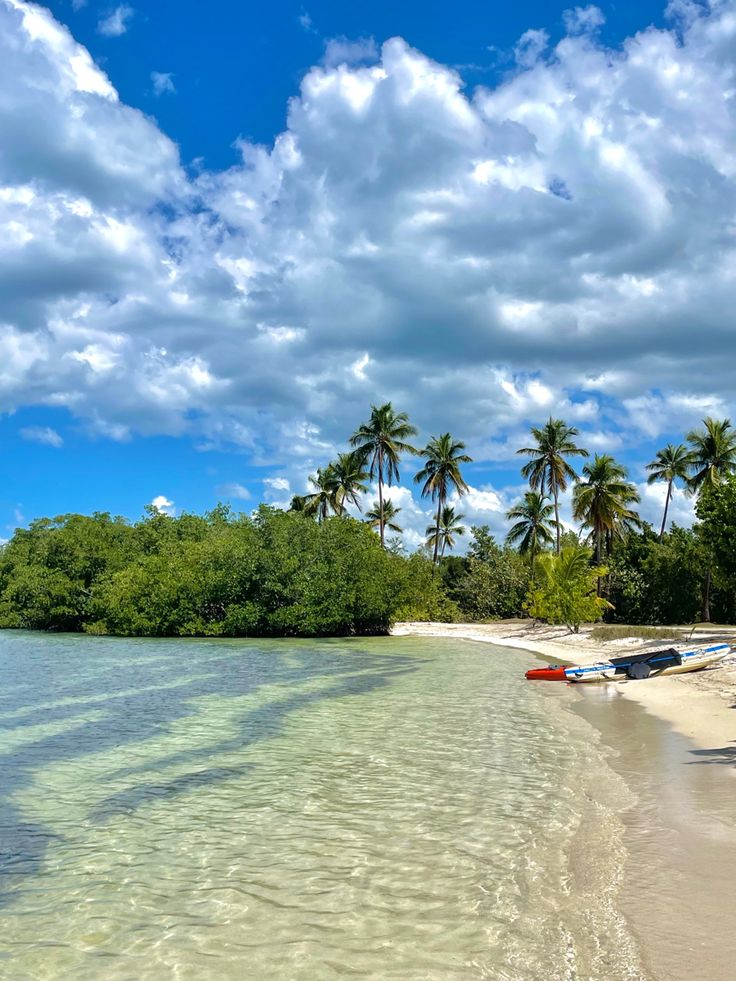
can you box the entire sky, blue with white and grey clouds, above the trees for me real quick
[0,0,736,545]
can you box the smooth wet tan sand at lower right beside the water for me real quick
[575,685,736,981]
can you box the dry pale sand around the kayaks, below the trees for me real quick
[392,620,736,764]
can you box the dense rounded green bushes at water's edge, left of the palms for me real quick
[0,506,455,636]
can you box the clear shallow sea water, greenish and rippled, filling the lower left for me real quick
[0,633,724,981]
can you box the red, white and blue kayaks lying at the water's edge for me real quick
[526,644,731,682]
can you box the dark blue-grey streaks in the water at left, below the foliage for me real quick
[0,641,422,908]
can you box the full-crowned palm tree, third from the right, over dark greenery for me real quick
[572,453,641,593]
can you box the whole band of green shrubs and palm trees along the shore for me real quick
[0,403,736,637]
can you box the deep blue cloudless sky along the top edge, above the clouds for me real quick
[43,0,664,168]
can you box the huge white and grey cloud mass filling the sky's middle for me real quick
[0,0,736,533]
